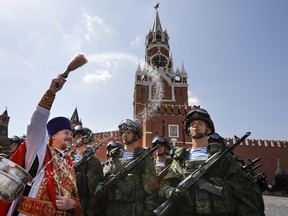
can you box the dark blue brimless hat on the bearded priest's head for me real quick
[47,117,72,137]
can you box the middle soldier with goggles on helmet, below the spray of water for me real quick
[100,119,159,216]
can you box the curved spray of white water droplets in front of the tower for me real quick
[135,66,164,124]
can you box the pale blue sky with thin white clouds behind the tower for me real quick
[0,0,288,140]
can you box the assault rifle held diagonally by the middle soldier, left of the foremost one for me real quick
[96,145,159,199]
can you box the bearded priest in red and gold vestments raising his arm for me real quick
[0,74,80,216]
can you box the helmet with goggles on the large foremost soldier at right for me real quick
[184,108,215,136]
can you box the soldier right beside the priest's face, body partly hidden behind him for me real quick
[73,125,104,216]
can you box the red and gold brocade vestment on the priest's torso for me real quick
[1,145,80,216]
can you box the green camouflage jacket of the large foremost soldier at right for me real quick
[159,143,264,216]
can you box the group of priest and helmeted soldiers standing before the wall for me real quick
[0,74,265,216]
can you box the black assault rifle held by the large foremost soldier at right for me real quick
[154,132,251,216]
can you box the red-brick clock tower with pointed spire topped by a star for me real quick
[133,4,191,147]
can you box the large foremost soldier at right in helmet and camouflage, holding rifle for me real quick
[159,108,265,216]
